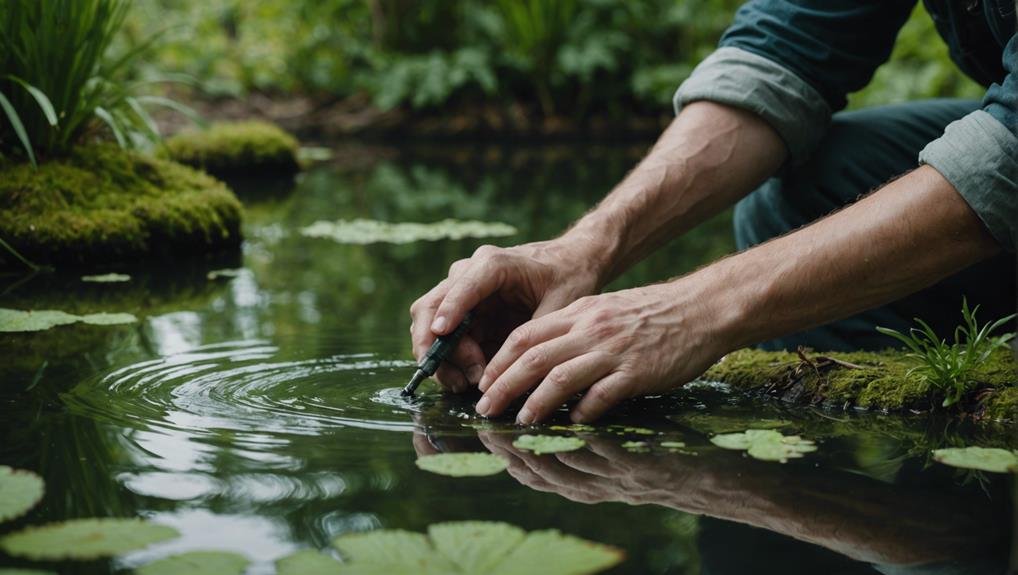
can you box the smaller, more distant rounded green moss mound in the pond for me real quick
[161,121,298,176]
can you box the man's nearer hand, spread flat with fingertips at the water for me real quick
[476,280,727,423]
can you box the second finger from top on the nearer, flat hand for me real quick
[475,335,589,417]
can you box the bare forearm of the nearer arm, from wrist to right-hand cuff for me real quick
[700,167,1000,349]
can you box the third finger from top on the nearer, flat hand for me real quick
[516,352,616,424]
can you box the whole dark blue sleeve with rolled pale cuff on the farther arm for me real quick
[674,0,916,164]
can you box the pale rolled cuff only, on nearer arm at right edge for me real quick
[919,110,1018,251]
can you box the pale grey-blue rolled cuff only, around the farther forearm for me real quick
[673,47,831,165]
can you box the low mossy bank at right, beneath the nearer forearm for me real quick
[703,349,1018,420]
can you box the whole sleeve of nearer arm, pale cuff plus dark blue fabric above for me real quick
[919,35,1018,251]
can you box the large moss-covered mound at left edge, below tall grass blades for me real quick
[0,145,241,268]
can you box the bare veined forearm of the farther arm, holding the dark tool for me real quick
[563,102,786,285]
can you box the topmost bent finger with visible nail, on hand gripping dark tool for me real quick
[429,248,510,336]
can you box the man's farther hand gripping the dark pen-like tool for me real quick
[410,238,601,392]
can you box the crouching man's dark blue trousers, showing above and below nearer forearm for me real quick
[735,100,1016,351]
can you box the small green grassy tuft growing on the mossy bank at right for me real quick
[876,298,1015,407]
